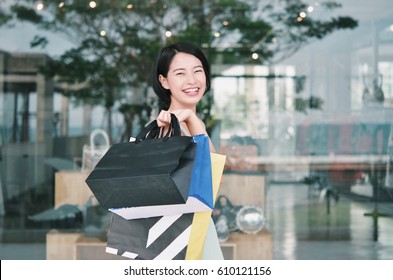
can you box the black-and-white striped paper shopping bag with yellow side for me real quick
[106,154,225,260]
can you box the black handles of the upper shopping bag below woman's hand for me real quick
[135,113,181,142]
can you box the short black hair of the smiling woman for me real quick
[152,42,211,110]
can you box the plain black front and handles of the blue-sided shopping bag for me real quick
[86,115,196,209]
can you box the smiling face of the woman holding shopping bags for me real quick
[159,52,206,110]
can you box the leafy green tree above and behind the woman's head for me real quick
[0,0,357,140]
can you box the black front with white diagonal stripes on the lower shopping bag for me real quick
[106,213,194,260]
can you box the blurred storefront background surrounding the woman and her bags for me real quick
[0,0,393,259]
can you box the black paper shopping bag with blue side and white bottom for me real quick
[86,115,214,219]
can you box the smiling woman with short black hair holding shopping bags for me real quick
[152,42,223,260]
